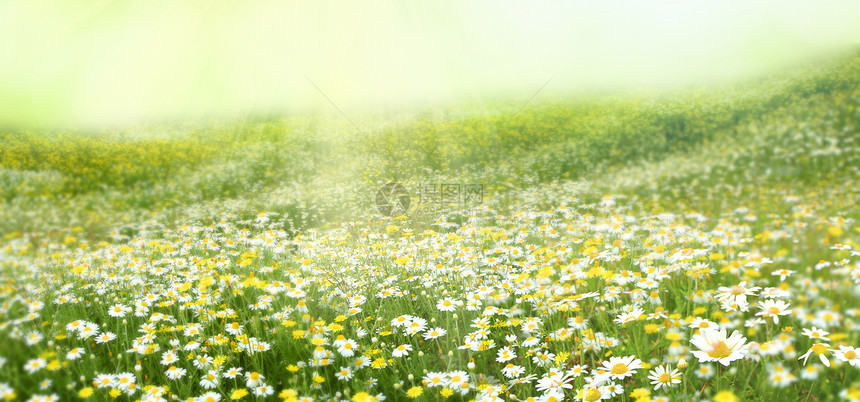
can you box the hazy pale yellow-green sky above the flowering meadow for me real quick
[0,0,860,127]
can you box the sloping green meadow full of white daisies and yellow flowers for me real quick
[0,57,860,402]
